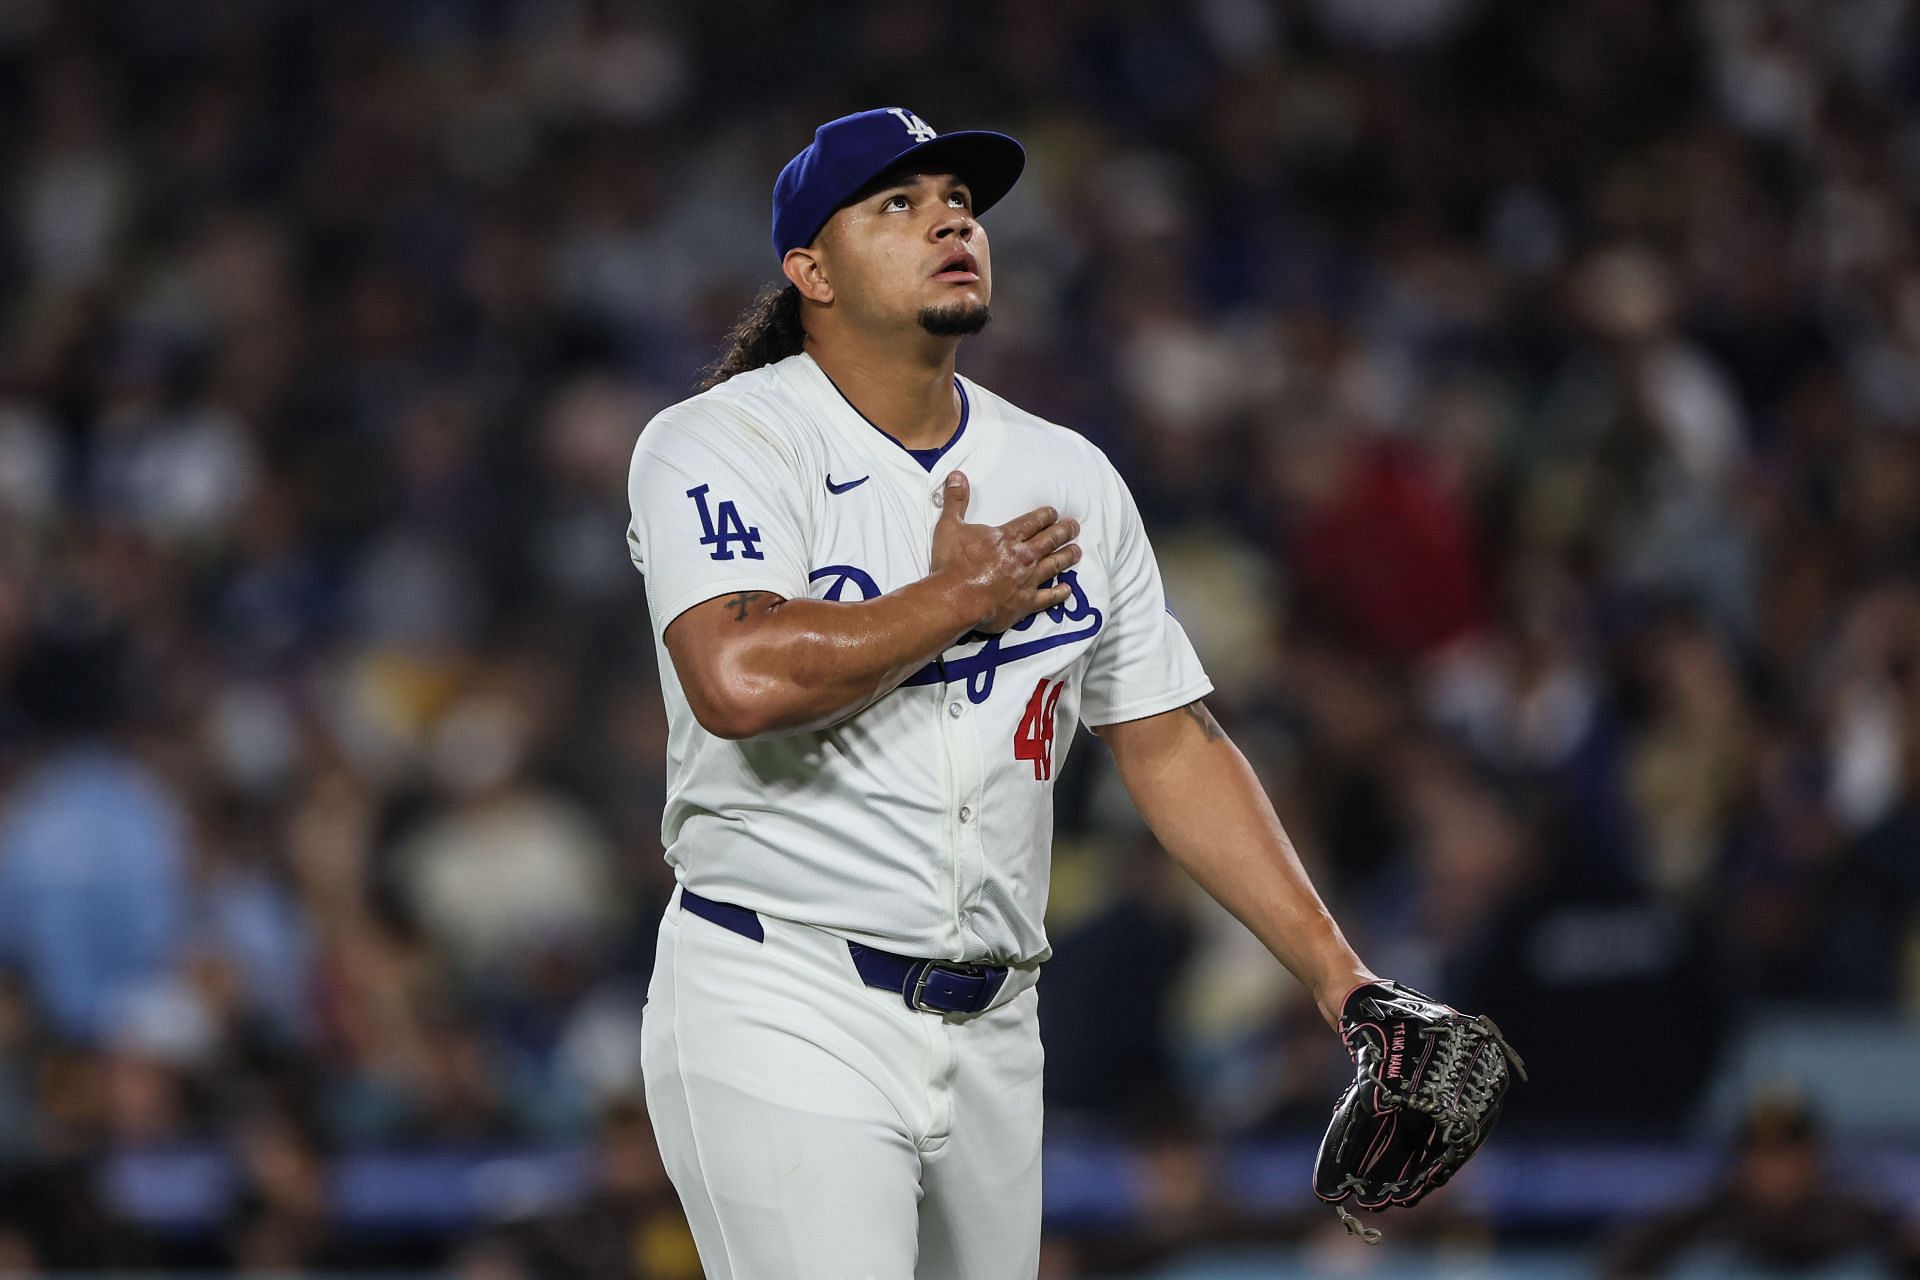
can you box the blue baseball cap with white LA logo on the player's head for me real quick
[774,107,1027,261]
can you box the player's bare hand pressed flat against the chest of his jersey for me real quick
[933,472,1081,635]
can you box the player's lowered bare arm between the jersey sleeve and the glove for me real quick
[1096,702,1375,1027]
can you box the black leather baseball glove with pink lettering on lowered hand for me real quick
[1313,983,1526,1244]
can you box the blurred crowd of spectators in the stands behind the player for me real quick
[0,0,1920,1280]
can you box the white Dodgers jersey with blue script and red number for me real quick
[628,355,1212,963]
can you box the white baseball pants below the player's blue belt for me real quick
[641,890,1041,1280]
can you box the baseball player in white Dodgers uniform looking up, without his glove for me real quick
[628,107,1373,1280]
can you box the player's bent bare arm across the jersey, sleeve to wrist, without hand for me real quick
[666,574,979,739]
